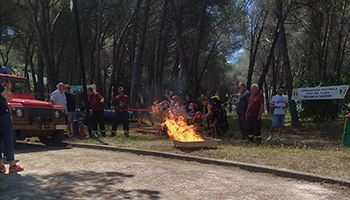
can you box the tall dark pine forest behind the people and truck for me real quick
[0,0,350,126]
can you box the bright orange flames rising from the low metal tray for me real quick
[162,113,204,142]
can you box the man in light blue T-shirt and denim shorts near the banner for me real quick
[267,86,288,143]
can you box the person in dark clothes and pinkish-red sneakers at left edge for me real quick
[0,81,24,173]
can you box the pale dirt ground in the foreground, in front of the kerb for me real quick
[0,144,350,200]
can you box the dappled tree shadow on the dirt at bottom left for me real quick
[0,170,160,200]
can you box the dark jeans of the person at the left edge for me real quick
[0,113,15,162]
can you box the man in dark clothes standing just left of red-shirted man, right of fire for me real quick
[231,83,250,142]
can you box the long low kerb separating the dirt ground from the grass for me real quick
[66,142,350,187]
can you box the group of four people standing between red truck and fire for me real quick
[51,82,130,138]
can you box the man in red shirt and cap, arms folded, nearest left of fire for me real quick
[111,87,130,137]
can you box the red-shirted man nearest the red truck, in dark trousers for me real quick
[87,87,106,138]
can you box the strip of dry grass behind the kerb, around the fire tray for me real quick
[67,114,350,179]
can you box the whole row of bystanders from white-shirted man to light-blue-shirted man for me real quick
[51,80,288,145]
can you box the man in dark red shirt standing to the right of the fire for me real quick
[246,84,264,145]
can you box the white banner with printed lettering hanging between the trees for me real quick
[292,85,349,100]
